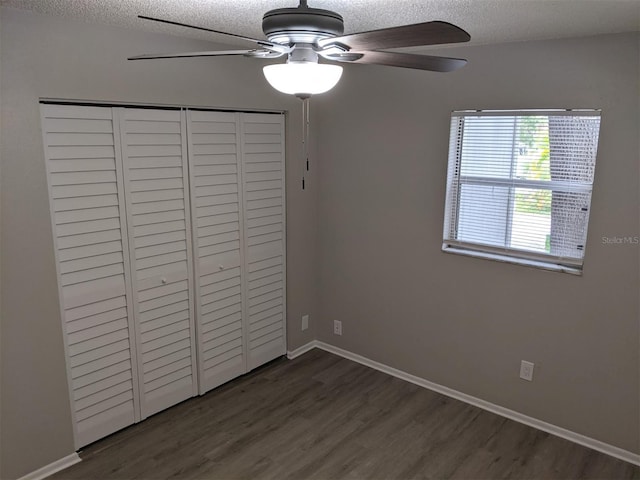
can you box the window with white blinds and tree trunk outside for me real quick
[442,110,600,273]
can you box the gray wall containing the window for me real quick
[317,34,640,453]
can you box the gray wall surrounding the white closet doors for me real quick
[0,9,317,478]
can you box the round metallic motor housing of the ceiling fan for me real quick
[262,6,344,45]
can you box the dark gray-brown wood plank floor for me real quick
[52,349,640,480]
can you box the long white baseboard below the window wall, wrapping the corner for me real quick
[287,340,640,465]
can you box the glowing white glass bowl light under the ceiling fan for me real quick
[262,62,342,95]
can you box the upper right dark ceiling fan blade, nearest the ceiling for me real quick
[318,21,471,51]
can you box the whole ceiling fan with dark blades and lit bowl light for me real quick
[129,0,471,99]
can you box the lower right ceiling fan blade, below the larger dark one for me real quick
[325,52,467,72]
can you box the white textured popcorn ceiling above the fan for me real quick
[0,0,640,44]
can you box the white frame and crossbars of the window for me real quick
[442,109,602,275]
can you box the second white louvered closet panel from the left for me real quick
[119,108,197,418]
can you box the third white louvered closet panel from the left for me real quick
[187,111,246,393]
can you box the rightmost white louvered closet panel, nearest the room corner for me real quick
[240,114,286,370]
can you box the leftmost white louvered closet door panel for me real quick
[41,105,139,448]
